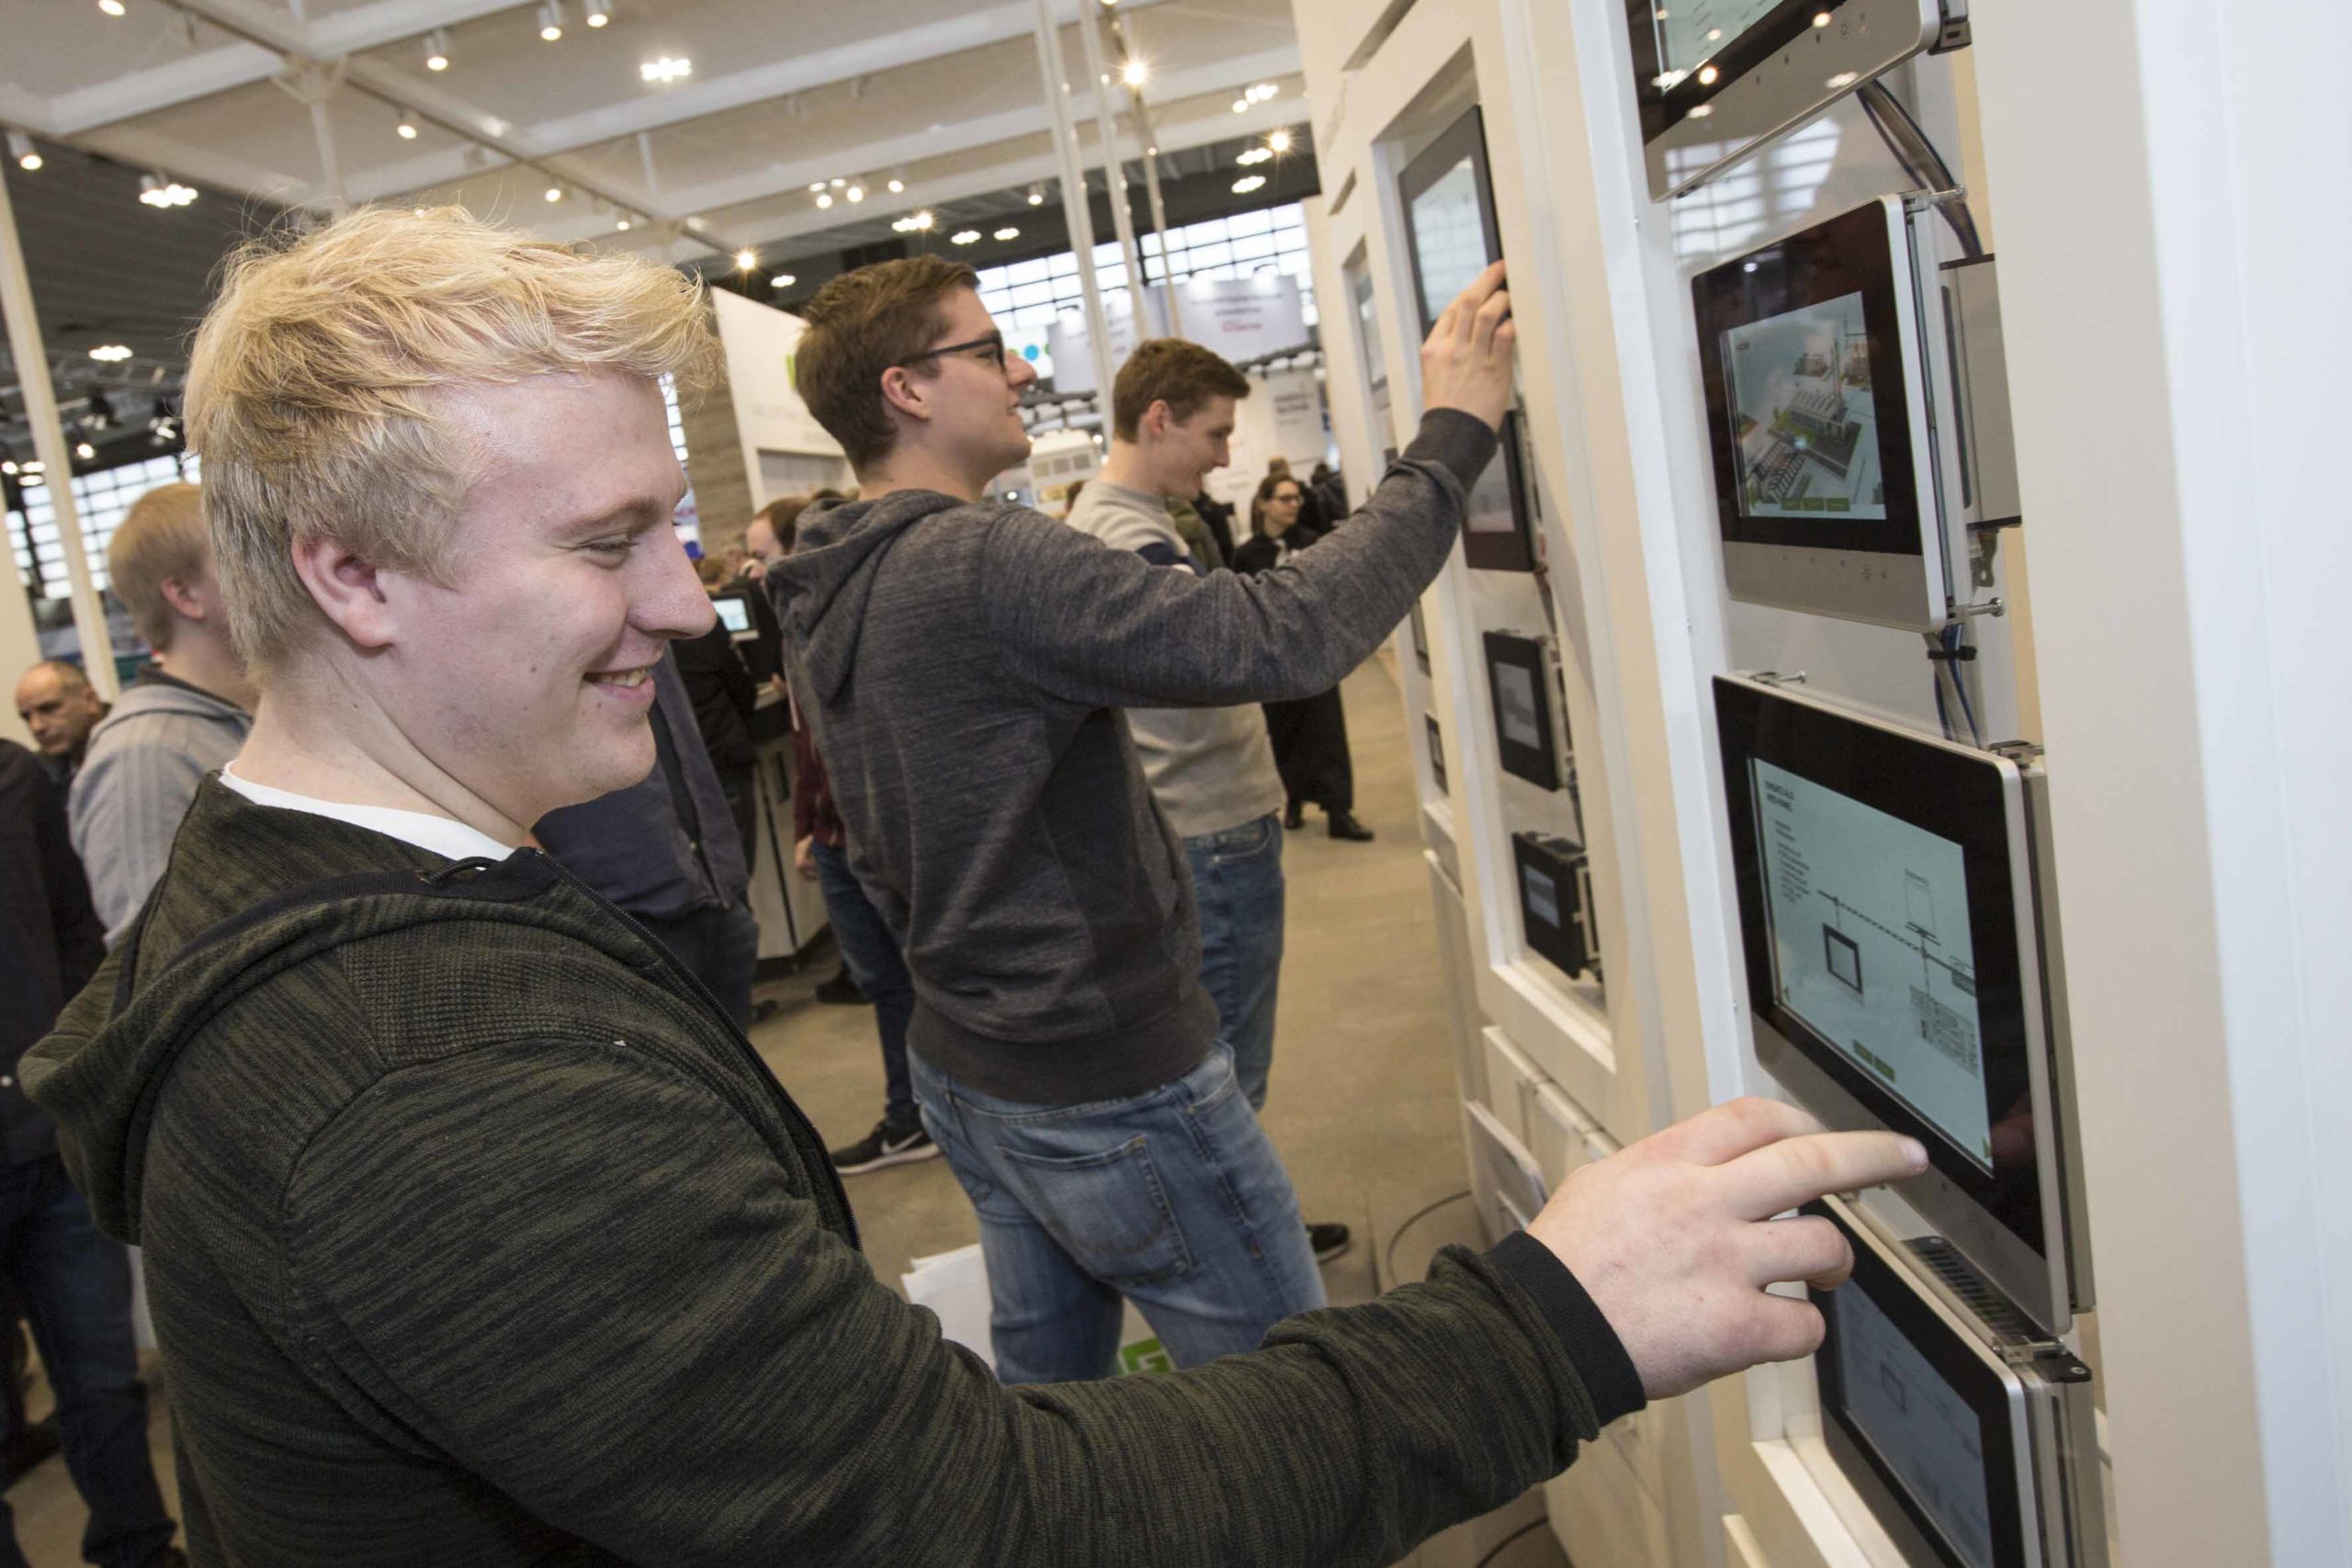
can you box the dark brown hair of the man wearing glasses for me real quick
[776,256,978,465]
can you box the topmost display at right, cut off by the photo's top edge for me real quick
[1625,0,1966,200]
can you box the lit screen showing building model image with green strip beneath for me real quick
[1724,294,1886,522]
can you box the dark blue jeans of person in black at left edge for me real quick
[0,1155,172,1568]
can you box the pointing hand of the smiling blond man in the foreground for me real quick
[1529,1100,1927,1399]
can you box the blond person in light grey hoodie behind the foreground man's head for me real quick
[68,484,254,945]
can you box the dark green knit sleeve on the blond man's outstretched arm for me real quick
[287,1042,1639,1568]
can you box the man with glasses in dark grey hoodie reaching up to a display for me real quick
[769,259,1512,1382]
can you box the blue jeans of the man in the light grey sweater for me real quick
[1183,811,1282,1110]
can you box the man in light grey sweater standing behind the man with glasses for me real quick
[1068,339,1348,1262]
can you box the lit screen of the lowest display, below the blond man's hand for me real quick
[1835,1283,1996,1568]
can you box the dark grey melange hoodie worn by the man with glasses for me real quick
[769,409,1496,1105]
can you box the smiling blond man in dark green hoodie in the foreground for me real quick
[26,211,1924,1568]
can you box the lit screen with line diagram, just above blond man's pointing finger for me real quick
[1750,760,1992,1173]
